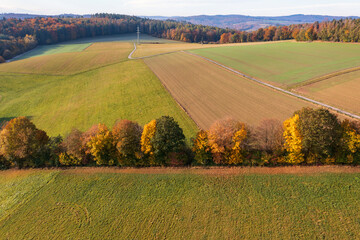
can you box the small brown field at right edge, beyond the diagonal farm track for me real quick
[295,71,360,114]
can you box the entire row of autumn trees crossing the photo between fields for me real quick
[0,108,360,168]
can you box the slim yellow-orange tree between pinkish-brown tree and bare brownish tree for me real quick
[229,124,248,165]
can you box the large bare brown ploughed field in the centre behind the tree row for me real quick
[144,53,310,129]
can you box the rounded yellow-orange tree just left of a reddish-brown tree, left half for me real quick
[87,124,116,166]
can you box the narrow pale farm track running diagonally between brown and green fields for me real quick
[181,51,360,119]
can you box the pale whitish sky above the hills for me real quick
[0,0,360,16]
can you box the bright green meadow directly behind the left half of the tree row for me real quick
[0,60,197,137]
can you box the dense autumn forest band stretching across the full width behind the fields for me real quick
[0,14,360,63]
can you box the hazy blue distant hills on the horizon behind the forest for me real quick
[148,14,359,31]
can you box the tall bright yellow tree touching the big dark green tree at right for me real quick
[284,114,304,165]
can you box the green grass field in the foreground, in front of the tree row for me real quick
[0,168,360,239]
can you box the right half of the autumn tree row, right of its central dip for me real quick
[192,108,360,166]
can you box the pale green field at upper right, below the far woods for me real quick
[190,42,360,86]
